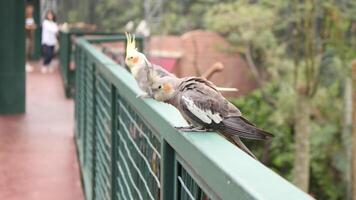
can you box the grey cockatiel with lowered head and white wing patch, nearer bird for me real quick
[151,77,273,158]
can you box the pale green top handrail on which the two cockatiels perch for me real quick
[77,38,313,200]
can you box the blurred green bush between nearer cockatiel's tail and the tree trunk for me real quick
[231,85,293,179]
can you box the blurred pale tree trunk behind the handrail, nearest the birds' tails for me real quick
[293,94,310,192]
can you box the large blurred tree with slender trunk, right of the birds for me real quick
[205,0,355,199]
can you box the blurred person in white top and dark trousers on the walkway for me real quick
[41,10,59,73]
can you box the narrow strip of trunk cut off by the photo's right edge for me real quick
[352,60,356,200]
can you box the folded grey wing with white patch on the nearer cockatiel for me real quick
[179,79,273,140]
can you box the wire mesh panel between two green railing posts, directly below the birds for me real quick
[115,96,161,200]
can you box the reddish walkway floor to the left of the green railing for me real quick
[0,62,83,200]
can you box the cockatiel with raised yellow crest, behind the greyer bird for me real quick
[125,33,175,97]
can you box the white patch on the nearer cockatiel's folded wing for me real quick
[182,96,223,124]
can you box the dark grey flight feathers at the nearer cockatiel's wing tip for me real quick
[220,116,273,140]
